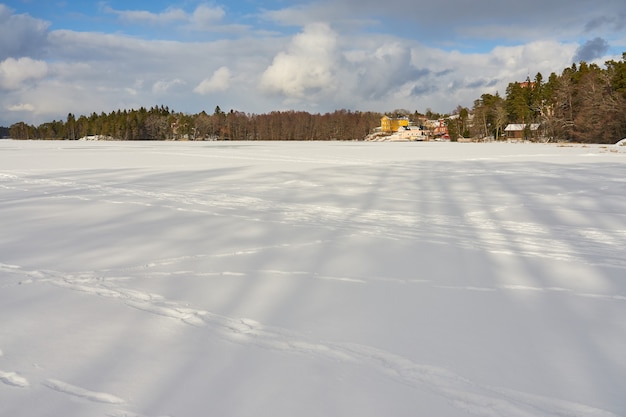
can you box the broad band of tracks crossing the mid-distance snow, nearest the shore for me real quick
[2,170,626,269]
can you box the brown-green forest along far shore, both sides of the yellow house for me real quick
[5,52,626,143]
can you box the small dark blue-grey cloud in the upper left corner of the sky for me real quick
[0,4,50,60]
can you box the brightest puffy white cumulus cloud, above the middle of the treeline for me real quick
[260,23,337,98]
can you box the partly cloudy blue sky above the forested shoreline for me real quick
[0,0,626,126]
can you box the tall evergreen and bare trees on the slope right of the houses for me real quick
[448,53,626,143]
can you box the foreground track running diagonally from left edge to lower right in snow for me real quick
[0,260,626,417]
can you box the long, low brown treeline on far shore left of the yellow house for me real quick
[10,106,382,140]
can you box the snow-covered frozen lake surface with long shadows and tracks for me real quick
[0,140,626,417]
